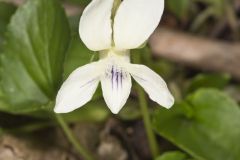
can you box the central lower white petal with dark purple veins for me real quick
[101,65,132,114]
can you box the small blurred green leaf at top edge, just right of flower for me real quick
[166,0,191,19]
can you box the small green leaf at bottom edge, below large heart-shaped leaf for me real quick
[156,151,187,160]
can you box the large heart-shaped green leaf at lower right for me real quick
[153,89,240,160]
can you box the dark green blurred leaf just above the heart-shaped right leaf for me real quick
[188,74,231,92]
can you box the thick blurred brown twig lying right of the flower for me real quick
[149,28,240,80]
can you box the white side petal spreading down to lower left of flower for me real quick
[54,62,101,113]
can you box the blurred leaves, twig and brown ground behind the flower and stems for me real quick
[0,0,240,160]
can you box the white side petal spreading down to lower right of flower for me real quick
[128,64,174,108]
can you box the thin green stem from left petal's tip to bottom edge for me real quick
[55,114,94,160]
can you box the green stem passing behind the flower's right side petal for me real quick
[133,53,159,158]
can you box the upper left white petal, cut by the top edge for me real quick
[79,0,114,51]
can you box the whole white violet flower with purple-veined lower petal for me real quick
[54,0,174,114]
